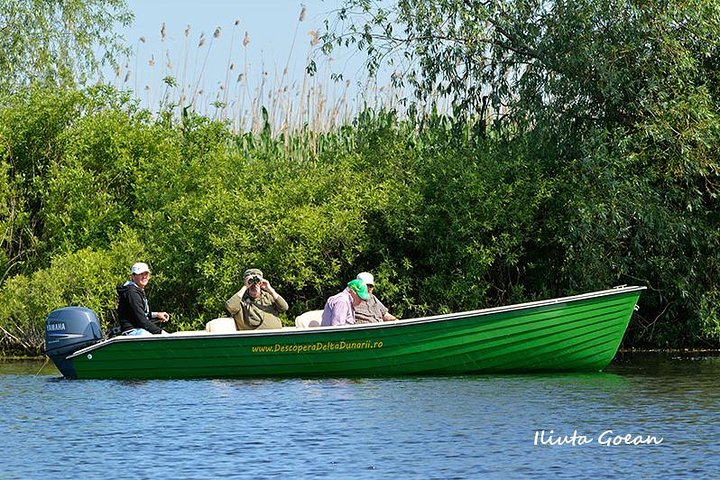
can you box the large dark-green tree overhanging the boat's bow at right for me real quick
[323,0,720,345]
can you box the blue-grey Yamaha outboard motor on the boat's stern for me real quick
[45,307,103,378]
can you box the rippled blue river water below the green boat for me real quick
[0,353,720,479]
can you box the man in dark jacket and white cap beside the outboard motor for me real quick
[117,262,170,335]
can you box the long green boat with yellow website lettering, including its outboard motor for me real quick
[46,286,645,379]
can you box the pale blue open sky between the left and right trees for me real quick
[111,0,372,128]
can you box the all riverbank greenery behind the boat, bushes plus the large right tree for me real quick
[0,0,720,354]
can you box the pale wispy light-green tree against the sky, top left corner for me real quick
[0,0,133,93]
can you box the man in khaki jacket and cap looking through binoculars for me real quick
[225,268,288,330]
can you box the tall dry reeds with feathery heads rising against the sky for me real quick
[111,6,399,138]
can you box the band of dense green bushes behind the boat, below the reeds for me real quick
[0,85,720,353]
